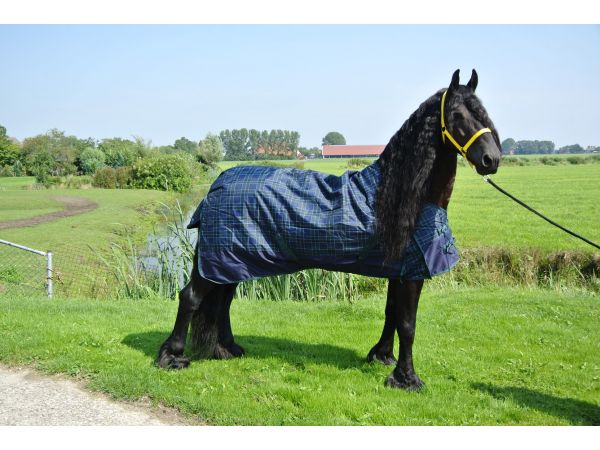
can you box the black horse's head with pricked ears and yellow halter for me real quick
[440,69,502,175]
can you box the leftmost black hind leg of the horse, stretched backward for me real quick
[156,253,217,369]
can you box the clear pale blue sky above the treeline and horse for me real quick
[0,25,600,148]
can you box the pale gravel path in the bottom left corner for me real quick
[0,366,192,426]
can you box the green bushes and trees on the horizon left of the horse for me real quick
[0,125,320,180]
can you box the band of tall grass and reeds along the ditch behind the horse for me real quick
[102,202,600,302]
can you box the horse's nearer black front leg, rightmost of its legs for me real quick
[385,280,423,391]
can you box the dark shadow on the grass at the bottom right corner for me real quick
[471,383,600,425]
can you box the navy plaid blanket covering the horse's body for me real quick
[188,162,458,283]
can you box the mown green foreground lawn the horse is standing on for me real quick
[0,288,600,425]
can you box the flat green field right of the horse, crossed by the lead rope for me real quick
[448,164,600,252]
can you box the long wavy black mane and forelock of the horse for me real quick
[375,86,499,259]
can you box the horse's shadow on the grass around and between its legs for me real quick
[121,331,368,370]
